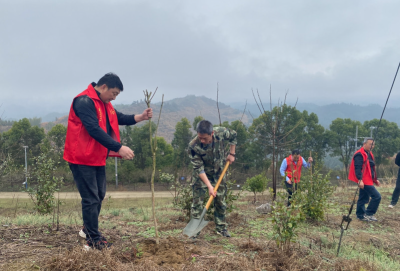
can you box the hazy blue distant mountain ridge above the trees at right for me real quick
[231,103,400,128]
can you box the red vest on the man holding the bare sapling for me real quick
[64,85,121,166]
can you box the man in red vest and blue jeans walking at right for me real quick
[349,137,381,221]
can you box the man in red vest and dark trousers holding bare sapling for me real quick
[64,73,153,250]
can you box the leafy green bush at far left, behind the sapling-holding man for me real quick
[27,153,62,214]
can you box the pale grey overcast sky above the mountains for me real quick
[0,0,400,118]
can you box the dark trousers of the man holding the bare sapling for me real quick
[69,164,106,242]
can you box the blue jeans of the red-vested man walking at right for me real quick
[356,185,381,218]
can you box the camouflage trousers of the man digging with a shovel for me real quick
[191,177,228,231]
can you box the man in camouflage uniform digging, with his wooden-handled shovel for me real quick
[183,120,237,239]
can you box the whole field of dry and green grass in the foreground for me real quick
[0,187,400,270]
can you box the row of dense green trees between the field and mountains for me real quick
[0,104,400,191]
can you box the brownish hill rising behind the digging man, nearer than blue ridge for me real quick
[42,95,251,143]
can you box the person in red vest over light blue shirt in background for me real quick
[280,150,313,206]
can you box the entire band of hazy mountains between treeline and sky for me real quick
[6,95,400,142]
